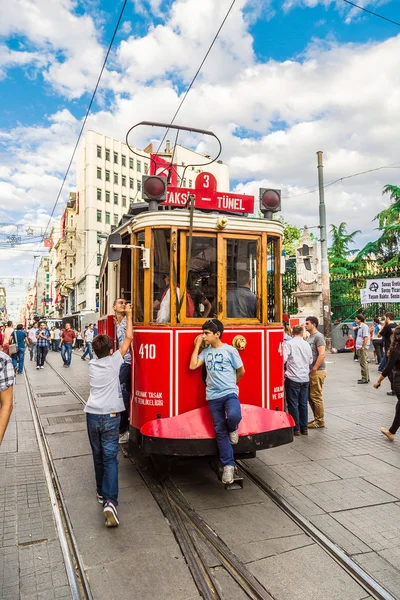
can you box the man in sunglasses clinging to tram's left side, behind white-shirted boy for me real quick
[113,298,132,444]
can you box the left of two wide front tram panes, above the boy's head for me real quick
[184,236,217,319]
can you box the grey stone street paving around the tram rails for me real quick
[0,353,400,600]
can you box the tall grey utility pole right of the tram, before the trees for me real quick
[317,151,332,350]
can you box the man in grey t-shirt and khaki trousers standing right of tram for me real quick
[305,317,326,429]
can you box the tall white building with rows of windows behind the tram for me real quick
[75,131,229,314]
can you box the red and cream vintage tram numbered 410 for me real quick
[99,125,294,456]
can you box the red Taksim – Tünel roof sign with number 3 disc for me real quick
[162,173,254,214]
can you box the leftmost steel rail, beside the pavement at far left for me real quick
[24,363,93,600]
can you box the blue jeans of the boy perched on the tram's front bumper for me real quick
[207,394,242,467]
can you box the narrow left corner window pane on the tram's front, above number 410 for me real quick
[152,229,171,323]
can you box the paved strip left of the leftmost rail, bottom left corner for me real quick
[0,375,71,600]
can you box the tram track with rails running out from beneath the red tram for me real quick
[47,363,395,600]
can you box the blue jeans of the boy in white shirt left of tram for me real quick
[86,413,120,506]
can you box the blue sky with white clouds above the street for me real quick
[0,0,400,316]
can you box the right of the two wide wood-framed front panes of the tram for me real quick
[226,239,257,319]
